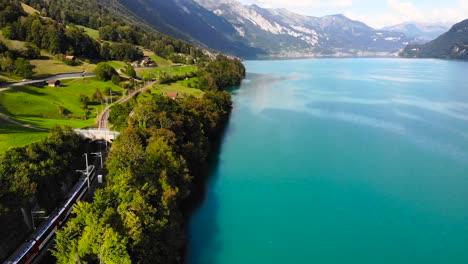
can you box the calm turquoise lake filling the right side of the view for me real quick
[188,59,468,264]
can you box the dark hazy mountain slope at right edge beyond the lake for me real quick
[400,19,468,60]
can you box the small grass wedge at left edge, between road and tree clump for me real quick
[0,121,47,153]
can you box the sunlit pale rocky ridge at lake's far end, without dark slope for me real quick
[195,0,415,56]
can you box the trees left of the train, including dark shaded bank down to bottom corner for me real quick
[0,125,85,258]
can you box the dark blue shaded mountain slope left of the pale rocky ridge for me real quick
[118,0,262,57]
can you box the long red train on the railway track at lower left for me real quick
[5,165,96,264]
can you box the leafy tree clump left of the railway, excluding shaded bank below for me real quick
[0,127,81,214]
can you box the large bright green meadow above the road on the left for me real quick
[0,78,123,129]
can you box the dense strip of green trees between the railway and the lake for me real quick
[53,90,236,263]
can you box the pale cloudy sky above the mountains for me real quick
[240,0,468,28]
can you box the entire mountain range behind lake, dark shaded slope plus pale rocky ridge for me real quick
[109,0,417,58]
